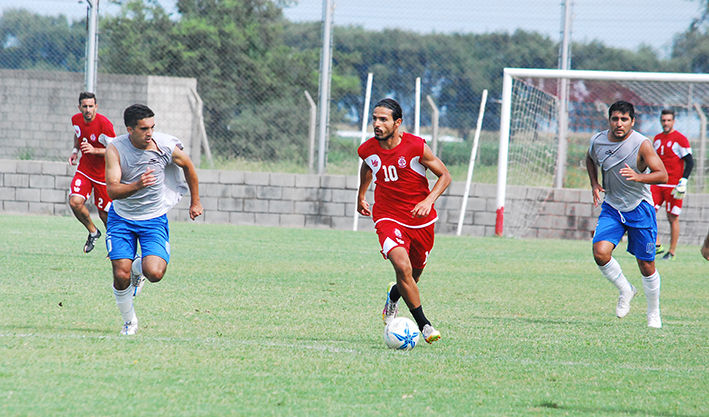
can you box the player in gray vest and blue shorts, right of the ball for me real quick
[586,101,667,328]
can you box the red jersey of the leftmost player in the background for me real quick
[71,113,116,183]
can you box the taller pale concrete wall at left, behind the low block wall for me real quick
[0,70,199,161]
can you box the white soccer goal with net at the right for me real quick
[495,68,709,236]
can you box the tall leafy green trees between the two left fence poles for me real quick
[104,0,324,159]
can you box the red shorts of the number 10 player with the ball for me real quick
[374,221,435,269]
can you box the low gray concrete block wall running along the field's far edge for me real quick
[0,159,709,245]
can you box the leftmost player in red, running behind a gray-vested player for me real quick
[69,92,116,253]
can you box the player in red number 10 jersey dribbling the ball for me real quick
[357,98,451,343]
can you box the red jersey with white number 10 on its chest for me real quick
[357,133,438,228]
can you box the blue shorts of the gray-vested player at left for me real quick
[106,206,170,263]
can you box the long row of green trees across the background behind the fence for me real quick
[6,0,709,166]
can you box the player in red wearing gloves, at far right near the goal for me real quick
[651,109,694,261]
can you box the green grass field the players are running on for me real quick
[0,215,709,416]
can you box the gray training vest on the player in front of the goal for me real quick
[588,130,653,212]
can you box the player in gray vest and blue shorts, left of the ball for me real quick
[106,104,202,335]
